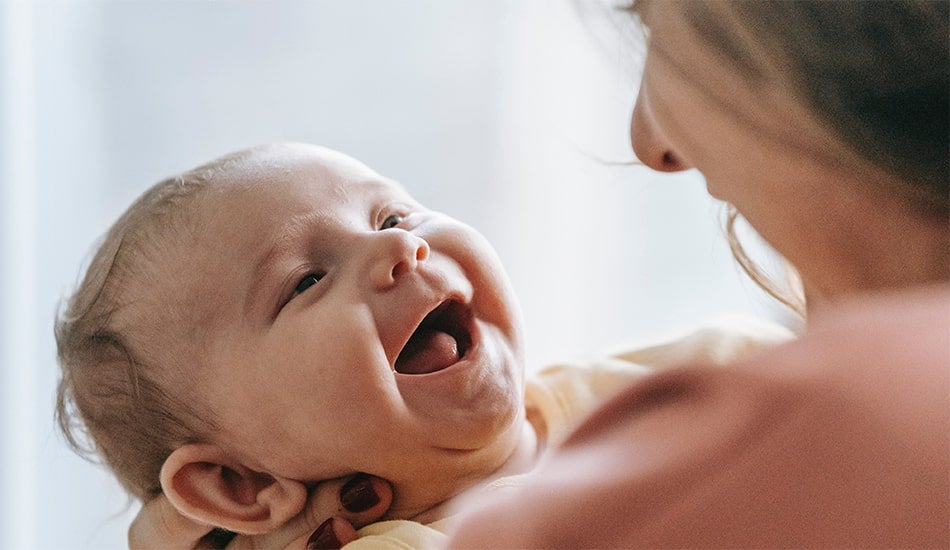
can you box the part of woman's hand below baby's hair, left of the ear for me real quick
[129,495,211,550]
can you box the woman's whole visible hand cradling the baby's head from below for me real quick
[129,474,392,550]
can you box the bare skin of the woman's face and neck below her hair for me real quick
[130,3,950,541]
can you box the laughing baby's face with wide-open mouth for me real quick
[168,145,523,512]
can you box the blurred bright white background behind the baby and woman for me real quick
[0,0,781,549]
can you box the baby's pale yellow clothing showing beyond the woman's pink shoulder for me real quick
[345,317,793,550]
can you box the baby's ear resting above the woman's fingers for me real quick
[161,443,307,534]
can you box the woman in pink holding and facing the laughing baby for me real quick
[131,2,950,548]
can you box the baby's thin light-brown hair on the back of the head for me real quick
[55,152,253,500]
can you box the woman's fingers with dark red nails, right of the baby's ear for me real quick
[228,474,393,550]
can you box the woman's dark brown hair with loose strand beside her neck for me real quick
[632,0,950,309]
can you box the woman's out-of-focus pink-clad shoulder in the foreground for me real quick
[454,287,950,547]
